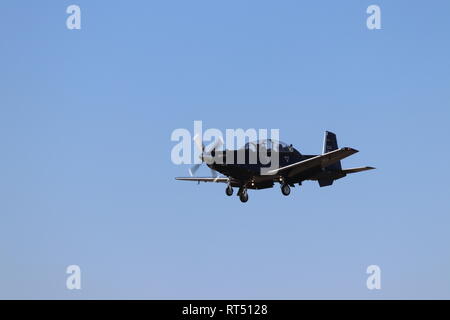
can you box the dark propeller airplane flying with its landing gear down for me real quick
[175,131,375,202]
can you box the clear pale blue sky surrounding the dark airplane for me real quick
[0,0,450,299]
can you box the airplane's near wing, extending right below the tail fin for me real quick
[267,147,358,177]
